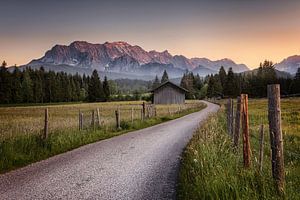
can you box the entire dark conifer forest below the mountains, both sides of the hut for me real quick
[0,60,300,104]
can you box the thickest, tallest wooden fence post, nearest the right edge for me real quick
[268,84,285,193]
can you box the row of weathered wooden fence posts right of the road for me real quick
[226,84,285,193]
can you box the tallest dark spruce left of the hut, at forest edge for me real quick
[88,70,102,102]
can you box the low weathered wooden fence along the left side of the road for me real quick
[39,102,199,139]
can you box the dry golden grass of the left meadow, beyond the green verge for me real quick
[0,101,199,139]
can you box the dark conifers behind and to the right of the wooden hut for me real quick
[152,60,300,99]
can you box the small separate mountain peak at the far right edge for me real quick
[275,55,300,74]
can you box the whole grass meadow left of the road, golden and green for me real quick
[0,101,205,173]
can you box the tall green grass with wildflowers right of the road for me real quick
[178,98,300,200]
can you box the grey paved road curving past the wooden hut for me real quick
[0,102,219,200]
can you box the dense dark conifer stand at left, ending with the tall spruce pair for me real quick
[0,62,111,104]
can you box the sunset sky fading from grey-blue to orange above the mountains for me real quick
[0,0,300,68]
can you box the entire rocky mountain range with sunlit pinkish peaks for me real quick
[13,41,300,80]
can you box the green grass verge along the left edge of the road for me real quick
[0,104,206,173]
